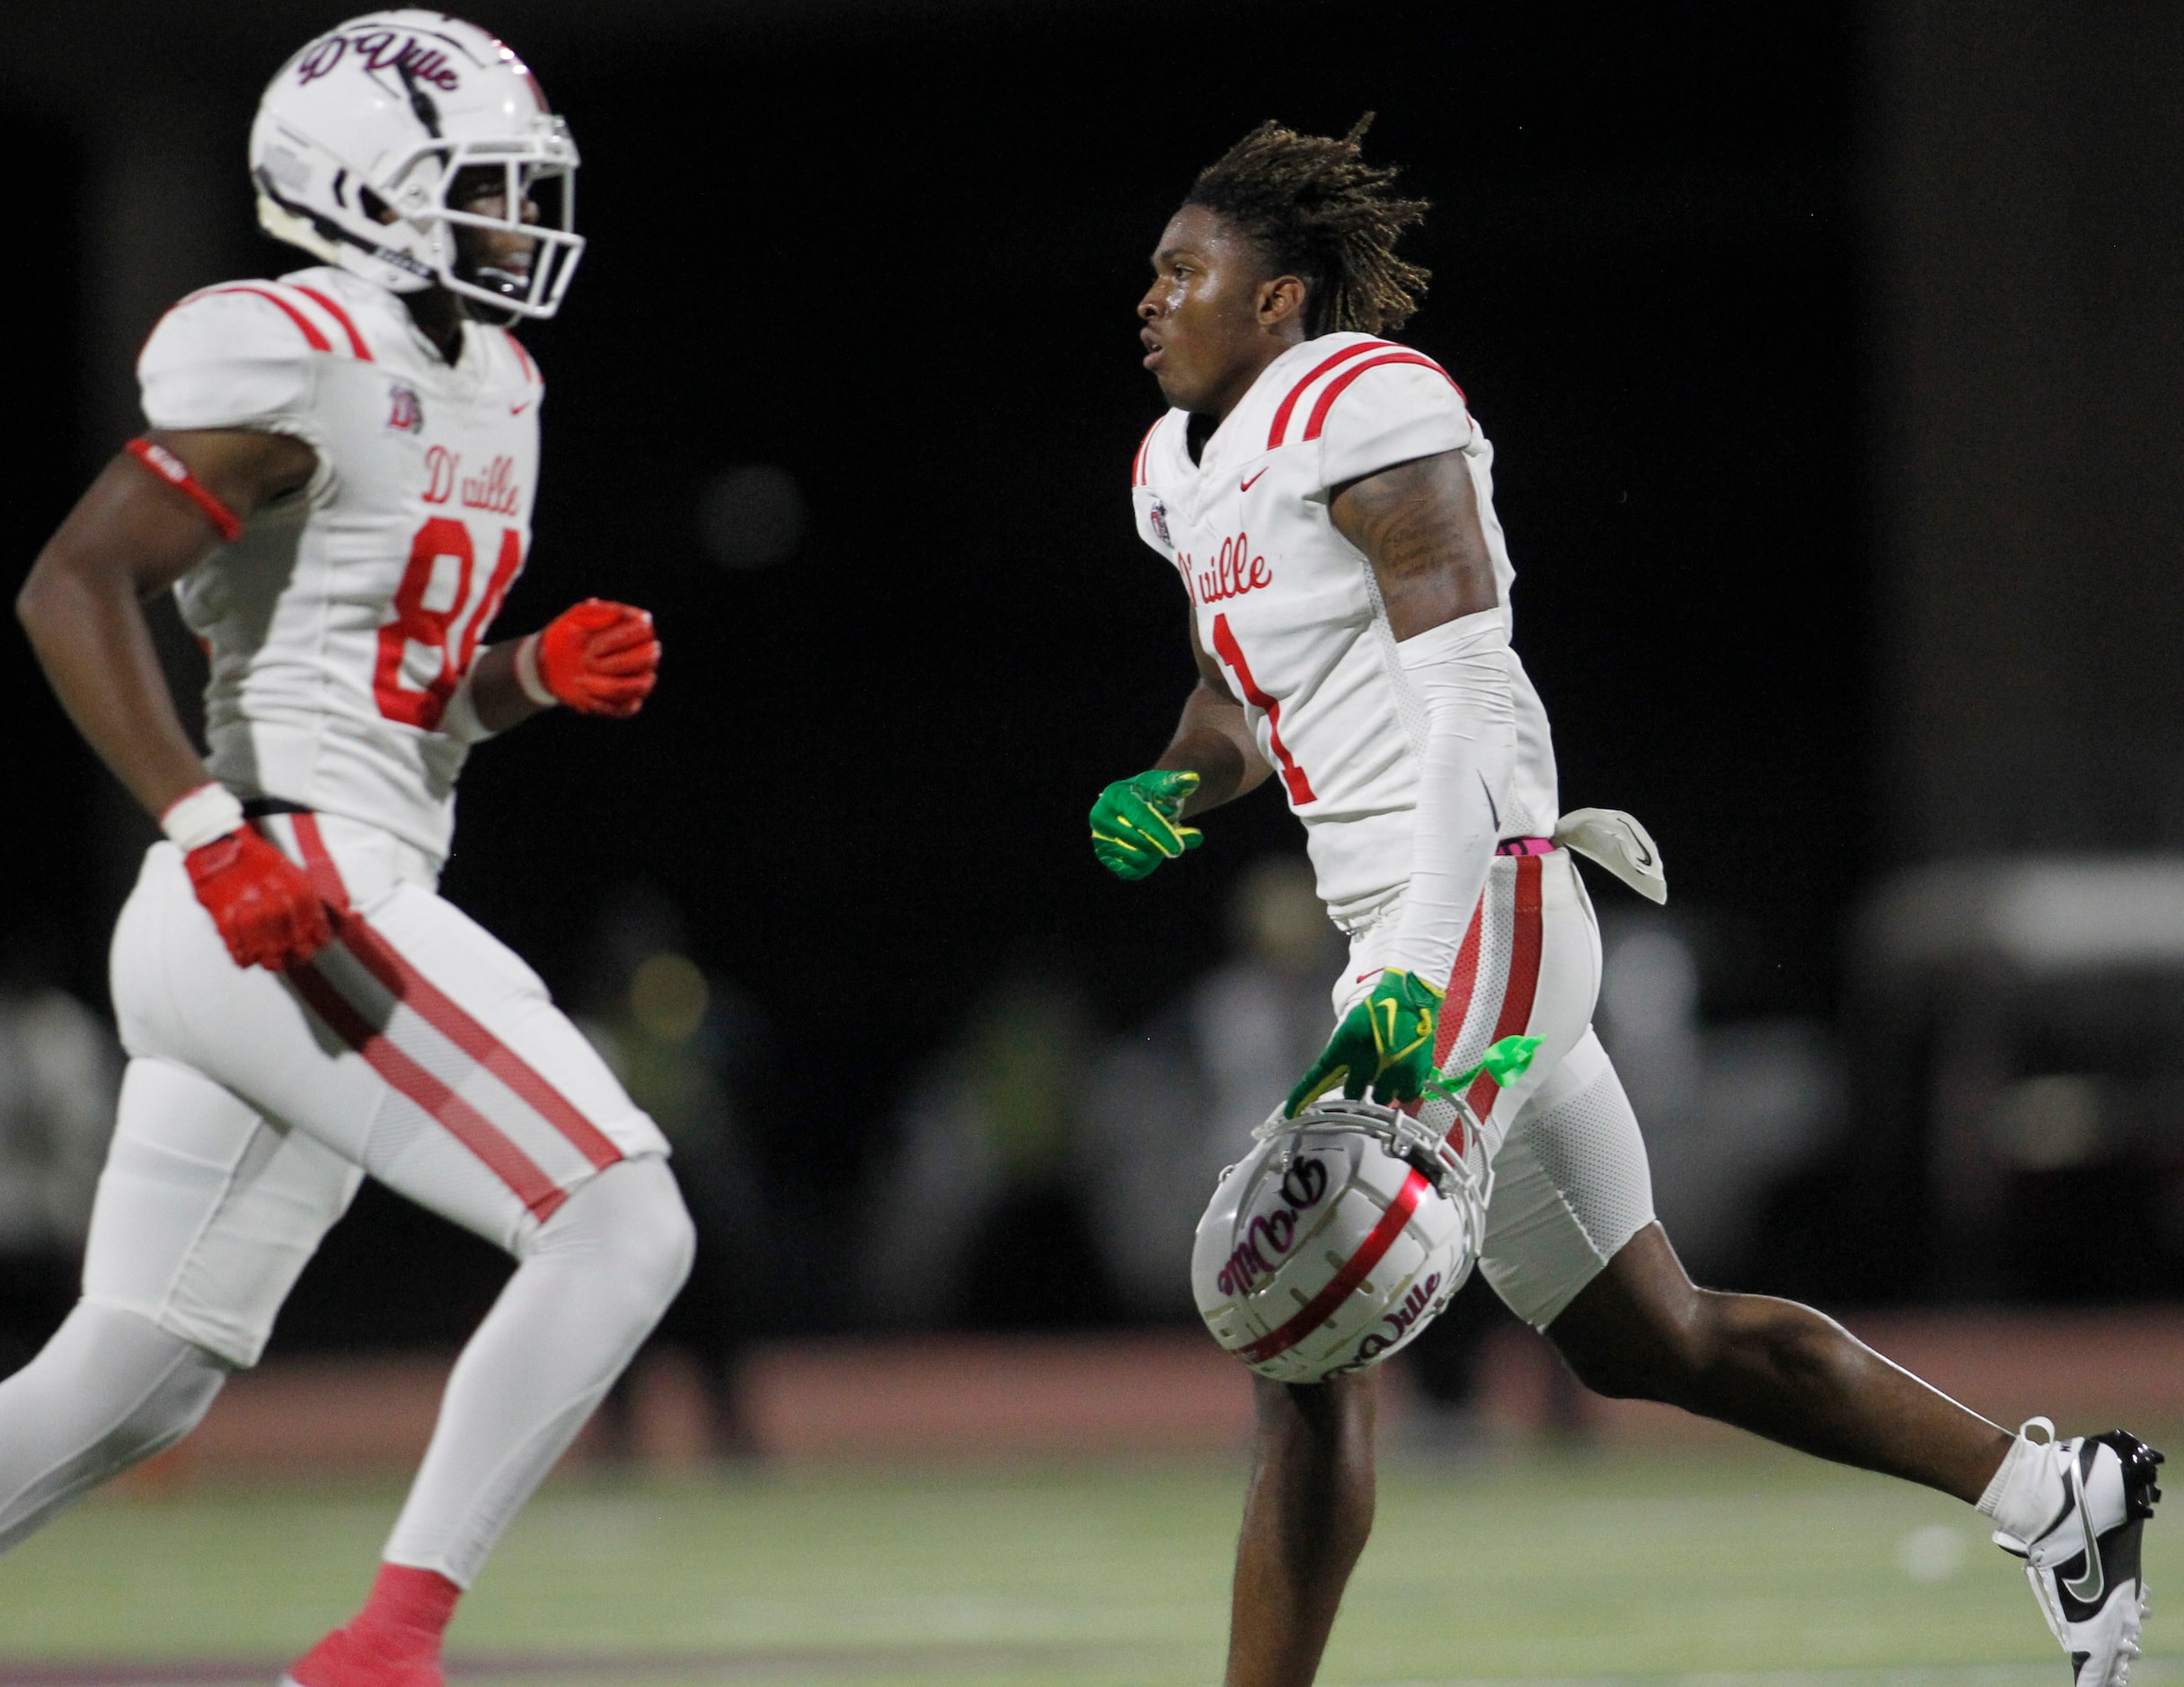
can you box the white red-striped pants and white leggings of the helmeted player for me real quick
[0,814,693,1585]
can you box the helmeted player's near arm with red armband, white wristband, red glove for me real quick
[15,428,332,969]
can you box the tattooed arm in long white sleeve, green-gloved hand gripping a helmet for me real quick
[1288,452,1514,1113]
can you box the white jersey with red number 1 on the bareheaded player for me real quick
[1131,334,1557,925]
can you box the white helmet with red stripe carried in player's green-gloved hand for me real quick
[1190,1096,1491,1382]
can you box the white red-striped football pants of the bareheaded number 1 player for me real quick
[1334,849,1653,1329]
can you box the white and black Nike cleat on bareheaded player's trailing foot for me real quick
[1994,1429,2162,1687]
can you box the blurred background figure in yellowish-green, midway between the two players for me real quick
[856,965,1111,1329]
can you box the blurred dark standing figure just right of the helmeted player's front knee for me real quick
[577,886,780,1453]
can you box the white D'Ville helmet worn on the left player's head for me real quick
[252,11,583,319]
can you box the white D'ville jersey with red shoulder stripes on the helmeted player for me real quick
[137,269,546,862]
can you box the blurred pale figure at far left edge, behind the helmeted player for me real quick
[0,929,122,1375]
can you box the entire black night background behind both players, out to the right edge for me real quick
[21,0,2184,1342]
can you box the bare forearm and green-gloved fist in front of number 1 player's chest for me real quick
[1092,615,1271,879]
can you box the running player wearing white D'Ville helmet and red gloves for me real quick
[0,11,693,1687]
